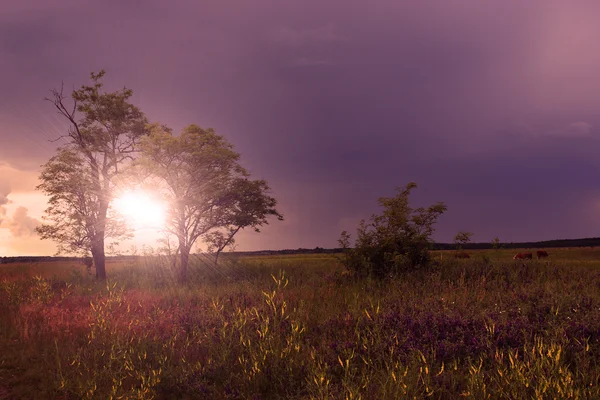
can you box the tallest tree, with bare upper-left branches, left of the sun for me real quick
[40,70,147,279]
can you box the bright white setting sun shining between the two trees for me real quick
[113,189,166,229]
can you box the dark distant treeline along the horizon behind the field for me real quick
[0,238,600,264]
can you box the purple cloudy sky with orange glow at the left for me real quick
[0,0,600,255]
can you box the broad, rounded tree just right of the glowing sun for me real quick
[138,124,282,281]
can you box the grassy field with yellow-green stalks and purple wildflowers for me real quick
[0,248,600,399]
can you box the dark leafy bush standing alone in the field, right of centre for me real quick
[339,182,447,278]
